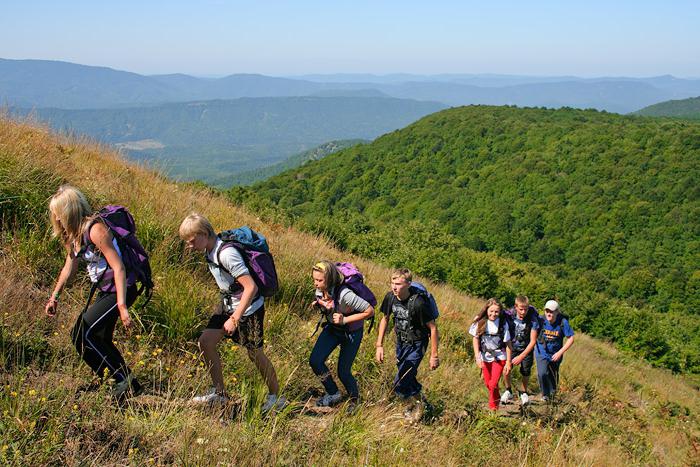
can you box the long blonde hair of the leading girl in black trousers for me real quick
[49,185,93,248]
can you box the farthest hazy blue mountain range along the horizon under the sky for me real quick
[0,59,700,113]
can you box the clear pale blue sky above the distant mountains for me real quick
[0,0,700,77]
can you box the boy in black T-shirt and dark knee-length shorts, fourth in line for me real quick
[376,268,440,423]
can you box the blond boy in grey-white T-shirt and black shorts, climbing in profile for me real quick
[179,213,287,413]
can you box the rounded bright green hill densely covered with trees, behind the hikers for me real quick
[233,106,700,371]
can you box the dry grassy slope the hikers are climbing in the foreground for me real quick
[0,119,700,465]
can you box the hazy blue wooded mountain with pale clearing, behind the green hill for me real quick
[12,97,445,186]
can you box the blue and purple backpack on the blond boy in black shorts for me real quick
[210,226,279,297]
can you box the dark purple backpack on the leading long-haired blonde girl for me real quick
[79,204,153,306]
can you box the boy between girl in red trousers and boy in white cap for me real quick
[501,295,540,406]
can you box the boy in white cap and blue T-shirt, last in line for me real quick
[535,300,574,402]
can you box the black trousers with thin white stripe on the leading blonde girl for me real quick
[71,285,138,382]
